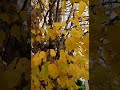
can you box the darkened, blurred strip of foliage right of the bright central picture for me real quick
[89,0,120,90]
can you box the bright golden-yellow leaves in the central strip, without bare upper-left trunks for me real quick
[31,0,89,90]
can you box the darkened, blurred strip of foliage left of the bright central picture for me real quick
[0,0,31,90]
